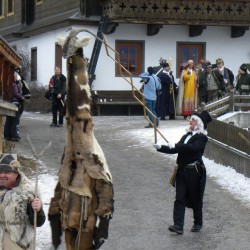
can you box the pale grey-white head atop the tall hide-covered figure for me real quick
[57,27,90,59]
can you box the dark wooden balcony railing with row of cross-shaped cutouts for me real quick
[103,0,250,26]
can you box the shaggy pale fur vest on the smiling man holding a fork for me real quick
[0,173,39,250]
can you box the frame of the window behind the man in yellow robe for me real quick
[176,42,206,78]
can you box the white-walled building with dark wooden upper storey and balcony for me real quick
[0,0,250,90]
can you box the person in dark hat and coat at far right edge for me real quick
[236,63,250,95]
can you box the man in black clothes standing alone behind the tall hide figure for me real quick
[49,66,66,127]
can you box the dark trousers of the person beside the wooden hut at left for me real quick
[4,111,21,139]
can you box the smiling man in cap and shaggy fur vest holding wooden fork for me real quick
[0,154,45,250]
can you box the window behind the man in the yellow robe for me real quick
[176,42,206,77]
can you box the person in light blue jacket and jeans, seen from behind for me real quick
[140,67,161,128]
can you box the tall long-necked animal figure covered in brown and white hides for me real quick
[49,28,114,250]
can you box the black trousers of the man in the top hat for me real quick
[174,167,203,227]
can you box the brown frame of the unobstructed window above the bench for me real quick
[115,40,145,77]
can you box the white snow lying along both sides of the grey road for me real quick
[29,115,250,250]
